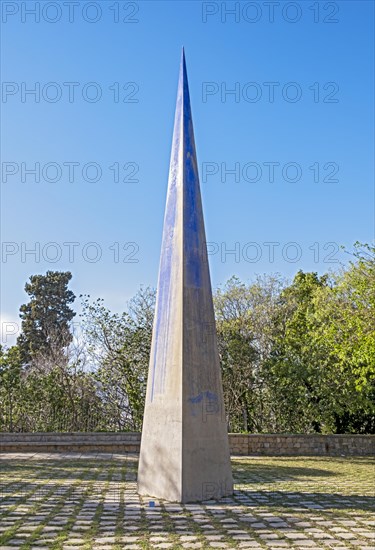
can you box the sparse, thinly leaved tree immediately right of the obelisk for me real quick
[214,274,285,432]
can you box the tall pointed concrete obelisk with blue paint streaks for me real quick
[138,51,233,502]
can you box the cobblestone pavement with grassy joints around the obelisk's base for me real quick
[0,453,375,550]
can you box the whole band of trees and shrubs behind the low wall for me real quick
[0,247,375,433]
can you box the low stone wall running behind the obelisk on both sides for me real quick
[0,432,375,456]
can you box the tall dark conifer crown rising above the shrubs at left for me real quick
[17,271,75,364]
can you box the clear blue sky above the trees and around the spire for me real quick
[1,0,374,343]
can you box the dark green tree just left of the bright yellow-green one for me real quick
[265,271,337,433]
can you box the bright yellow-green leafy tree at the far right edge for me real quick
[313,243,375,433]
